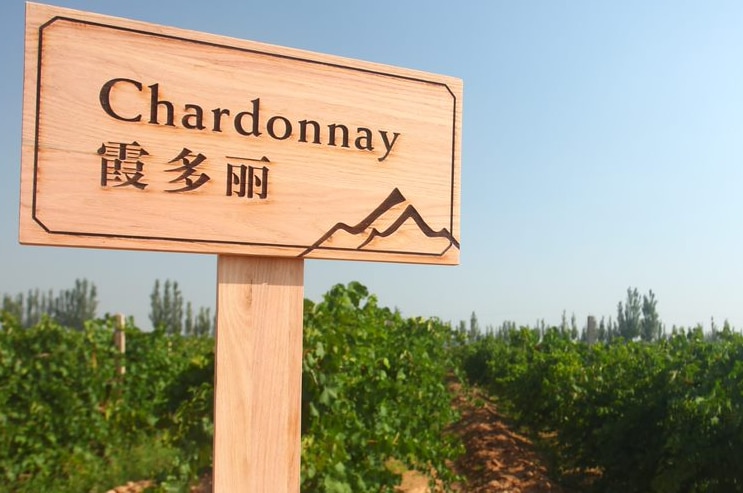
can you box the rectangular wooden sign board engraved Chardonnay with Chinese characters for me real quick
[20,4,462,264]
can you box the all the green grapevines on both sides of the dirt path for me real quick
[0,283,743,493]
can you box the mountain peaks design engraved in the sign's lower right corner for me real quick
[299,188,459,257]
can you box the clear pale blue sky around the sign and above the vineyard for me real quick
[0,0,743,328]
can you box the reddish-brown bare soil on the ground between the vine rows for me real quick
[107,383,568,493]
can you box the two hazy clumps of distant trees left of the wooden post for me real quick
[0,279,216,336]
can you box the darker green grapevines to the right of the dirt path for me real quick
[464,328,743,493]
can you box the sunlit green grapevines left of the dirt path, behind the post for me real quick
[0,283,462,493]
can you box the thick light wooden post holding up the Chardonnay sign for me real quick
[214,255,304,493]
